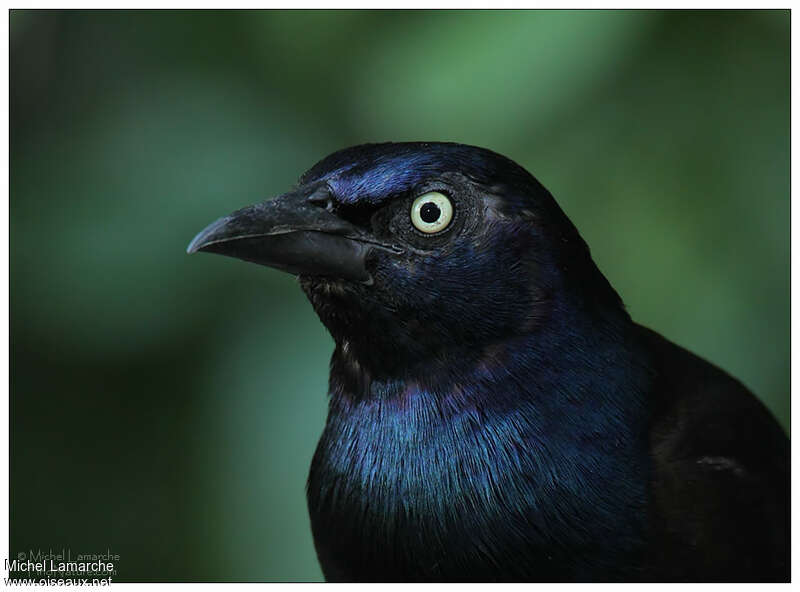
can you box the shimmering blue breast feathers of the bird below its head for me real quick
[308,308,649,581]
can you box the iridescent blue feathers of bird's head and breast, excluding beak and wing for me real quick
[301,144,648,580]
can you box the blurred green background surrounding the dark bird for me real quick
[10,11,790,581]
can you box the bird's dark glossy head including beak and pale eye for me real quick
[188,142,621,375]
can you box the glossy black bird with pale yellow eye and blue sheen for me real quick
[187,142,790,582]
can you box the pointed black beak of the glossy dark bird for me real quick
[186,186,398,283]
